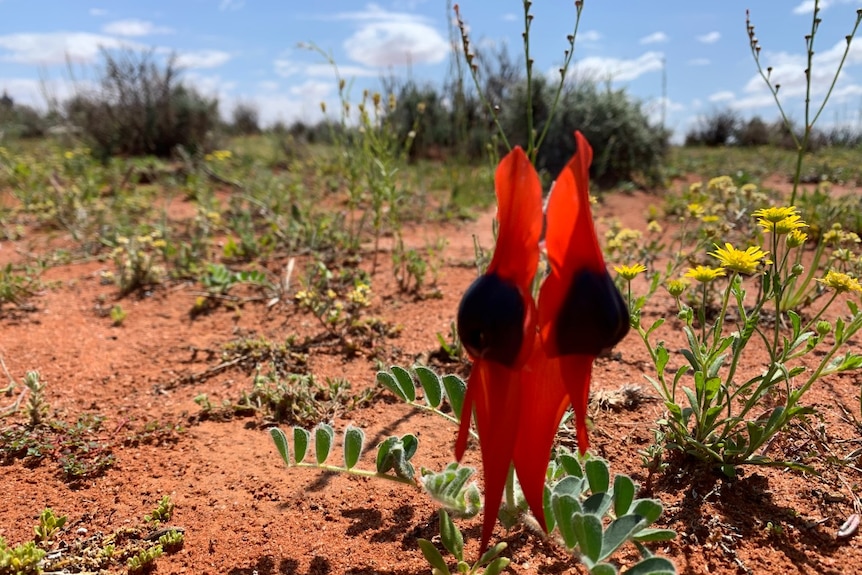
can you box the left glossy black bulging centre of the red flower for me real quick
[458,274,526,366]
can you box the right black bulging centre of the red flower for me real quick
[556,269,629,356]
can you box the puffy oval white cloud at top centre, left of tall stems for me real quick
[331,4,450,67]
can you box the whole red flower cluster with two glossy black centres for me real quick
[455,132,629,550]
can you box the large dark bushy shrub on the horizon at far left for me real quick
[66,50,219,158]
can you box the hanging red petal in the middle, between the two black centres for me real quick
[515,339,569,531]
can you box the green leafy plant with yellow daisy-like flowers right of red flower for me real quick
[627,207,862,476]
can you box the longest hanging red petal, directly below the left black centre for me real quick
[470,360,522,553]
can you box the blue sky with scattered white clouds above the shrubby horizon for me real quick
[0,0,862,141]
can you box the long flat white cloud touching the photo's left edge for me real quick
[0,32,144,65]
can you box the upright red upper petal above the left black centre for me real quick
[488,147,542,295]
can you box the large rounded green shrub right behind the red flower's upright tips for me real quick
[502,78,669,187]
